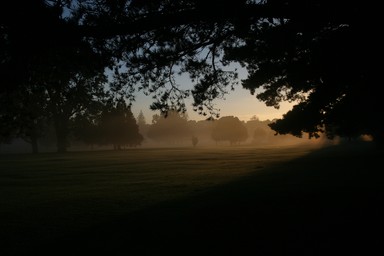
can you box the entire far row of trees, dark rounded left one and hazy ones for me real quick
[0,109,328,153]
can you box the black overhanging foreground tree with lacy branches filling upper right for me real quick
[76,0,383,143]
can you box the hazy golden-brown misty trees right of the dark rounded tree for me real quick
[138,112,318,146]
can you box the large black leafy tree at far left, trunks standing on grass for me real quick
[0,1,112,152]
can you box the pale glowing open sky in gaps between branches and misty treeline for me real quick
[132,67,294,123]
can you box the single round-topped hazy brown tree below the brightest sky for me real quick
[212,116,248,145]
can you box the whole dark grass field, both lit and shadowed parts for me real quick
[0,144,384,255]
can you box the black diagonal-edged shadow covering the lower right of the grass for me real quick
[3,145,384,255]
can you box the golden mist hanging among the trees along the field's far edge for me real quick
[0,111,344,153]
